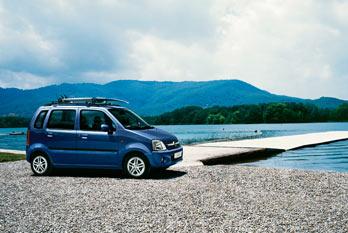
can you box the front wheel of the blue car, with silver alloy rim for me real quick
[123,153,151,179]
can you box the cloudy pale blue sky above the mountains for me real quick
[0,0,348,99]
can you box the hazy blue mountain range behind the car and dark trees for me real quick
[0,80,344,117]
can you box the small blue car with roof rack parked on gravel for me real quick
[26,98,183,178]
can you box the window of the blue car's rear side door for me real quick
[47,110,76,129]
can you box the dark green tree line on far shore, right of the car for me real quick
[146,103,348,125]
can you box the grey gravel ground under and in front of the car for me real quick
[0,161,348,232]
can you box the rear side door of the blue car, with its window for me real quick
[45,109,79,165]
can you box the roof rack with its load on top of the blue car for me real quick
[45,97,129,106]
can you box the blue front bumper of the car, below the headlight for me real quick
[149,147,184,168]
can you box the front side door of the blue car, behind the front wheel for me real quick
[76,109,121,167]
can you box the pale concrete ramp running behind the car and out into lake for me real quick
[0,131,348,167]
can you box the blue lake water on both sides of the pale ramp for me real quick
[0,123,348,172]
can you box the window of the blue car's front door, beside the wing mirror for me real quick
[80,110,115,131]
